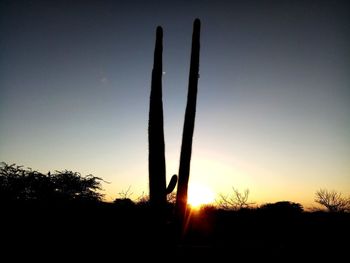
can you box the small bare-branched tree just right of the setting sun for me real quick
[216,187,255,210]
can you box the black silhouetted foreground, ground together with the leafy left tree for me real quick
[0,164,350,262]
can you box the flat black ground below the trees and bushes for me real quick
[1,203,350,262]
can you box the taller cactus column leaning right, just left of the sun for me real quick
[176,19,201,224]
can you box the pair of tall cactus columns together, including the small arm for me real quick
[148,18,200,231]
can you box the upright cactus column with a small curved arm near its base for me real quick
[148,26,177,210]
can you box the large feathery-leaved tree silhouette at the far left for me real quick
[0,162,103,202]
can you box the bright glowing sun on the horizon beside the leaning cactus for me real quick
[187,184,215,208]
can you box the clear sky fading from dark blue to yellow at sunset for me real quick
[0,0,350,205]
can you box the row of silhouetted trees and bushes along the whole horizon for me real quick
[0,162,350,212]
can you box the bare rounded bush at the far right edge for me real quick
[315,189,350,212]
